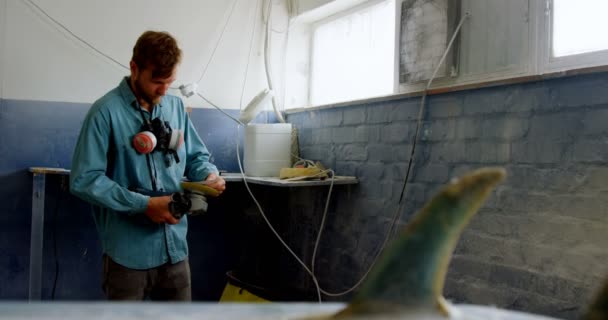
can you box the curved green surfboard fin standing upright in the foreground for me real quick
[334,168,506,318]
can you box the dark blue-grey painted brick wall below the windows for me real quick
[288,73,608,319]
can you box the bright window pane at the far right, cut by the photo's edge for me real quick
[553,0,608,57]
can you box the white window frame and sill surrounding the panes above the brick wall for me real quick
[287,0,608,110]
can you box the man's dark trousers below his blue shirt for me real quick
[102,254,192,301]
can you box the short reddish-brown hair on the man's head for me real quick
[131,31,182,78]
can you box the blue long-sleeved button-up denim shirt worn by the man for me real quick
[70,77,217,269]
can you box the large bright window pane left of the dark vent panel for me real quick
[311,1,395,105]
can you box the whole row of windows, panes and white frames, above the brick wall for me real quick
[285,0,608,108]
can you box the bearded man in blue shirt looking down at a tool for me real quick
[70,31,225,301]
